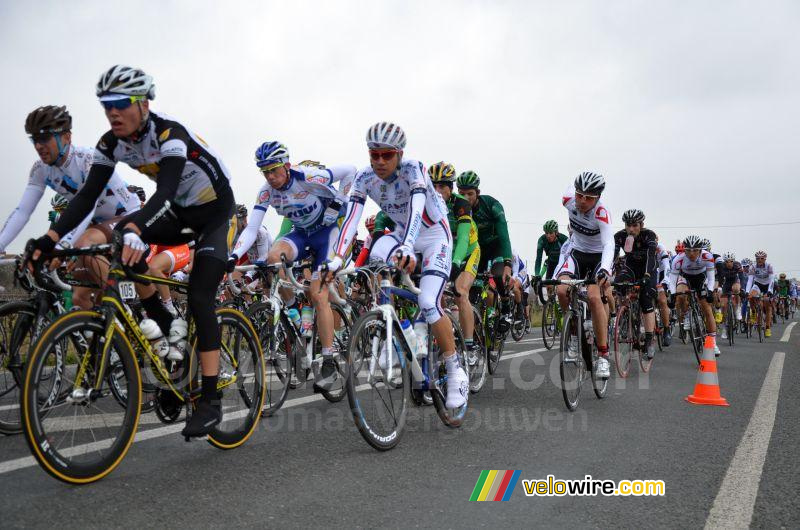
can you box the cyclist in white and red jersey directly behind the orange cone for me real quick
[669,235,720,356]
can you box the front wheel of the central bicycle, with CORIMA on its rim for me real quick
[346,311,409,451]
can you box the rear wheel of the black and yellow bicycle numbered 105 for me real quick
[193,307,266,449]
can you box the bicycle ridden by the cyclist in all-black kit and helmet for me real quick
[611,280,655,379]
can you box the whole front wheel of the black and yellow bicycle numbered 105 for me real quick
[22,311,142,484]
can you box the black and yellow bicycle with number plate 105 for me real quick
[21,239,265,484]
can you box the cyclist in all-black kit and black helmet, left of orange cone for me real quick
[614,209,669,359]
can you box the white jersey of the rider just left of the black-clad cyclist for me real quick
[561,186,614,273]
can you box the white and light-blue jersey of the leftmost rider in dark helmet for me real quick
[0,145,139,252]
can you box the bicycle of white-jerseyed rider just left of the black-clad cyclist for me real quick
[541,279,608,412]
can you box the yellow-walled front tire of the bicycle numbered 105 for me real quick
[22,311,142,484]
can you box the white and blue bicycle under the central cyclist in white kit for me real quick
[340,258,467,451]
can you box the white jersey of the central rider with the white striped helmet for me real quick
[336,159,450,256]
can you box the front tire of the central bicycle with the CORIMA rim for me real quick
[346,310,409,451]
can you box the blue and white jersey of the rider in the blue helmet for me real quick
[253,166,345,231]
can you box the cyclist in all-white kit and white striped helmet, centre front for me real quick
[329,122,469,408]
